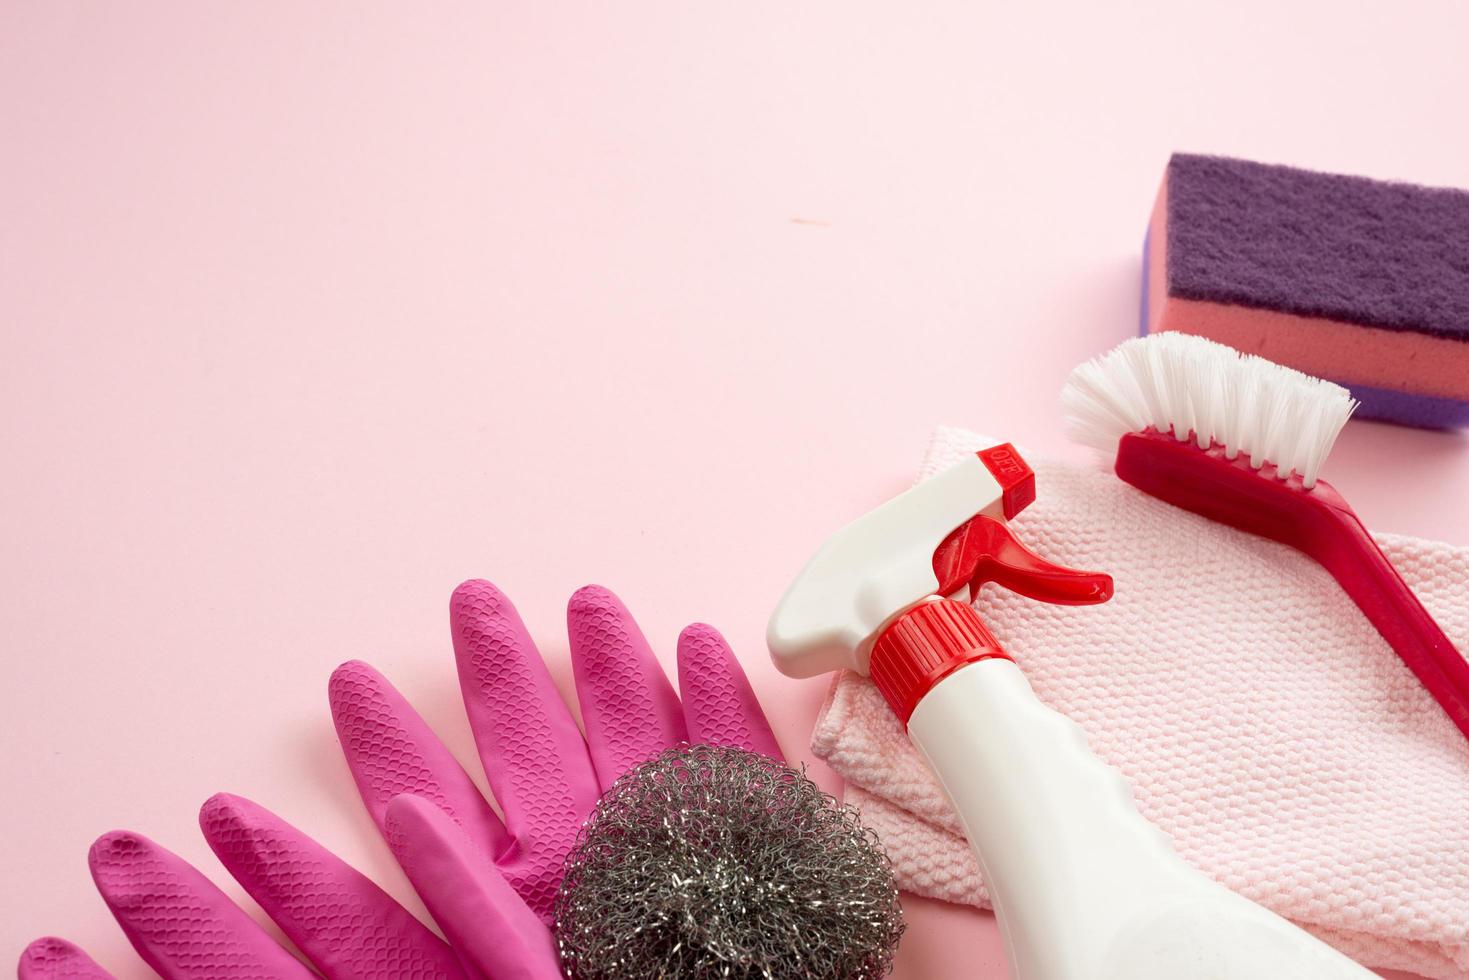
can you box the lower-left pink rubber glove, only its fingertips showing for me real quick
[19,793,469,980]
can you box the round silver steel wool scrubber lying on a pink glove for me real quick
[555,745,903,980]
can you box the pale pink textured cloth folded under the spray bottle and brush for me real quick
[812,429,1469,979]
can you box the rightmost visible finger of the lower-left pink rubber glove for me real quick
[198,793,466,980]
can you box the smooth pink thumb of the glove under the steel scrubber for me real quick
[388,796,561,980]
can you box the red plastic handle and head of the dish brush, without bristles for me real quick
[1116,430,1469,738]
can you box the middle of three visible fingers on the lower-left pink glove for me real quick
[88,830,316,980]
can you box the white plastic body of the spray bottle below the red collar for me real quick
[908,658,1375,980]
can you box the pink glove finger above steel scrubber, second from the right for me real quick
[566,585,689,789]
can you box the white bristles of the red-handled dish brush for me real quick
[1061,332,1357,489]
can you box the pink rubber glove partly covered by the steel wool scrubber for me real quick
[331,580,780,977]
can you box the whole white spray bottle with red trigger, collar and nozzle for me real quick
[768,445,1375,980]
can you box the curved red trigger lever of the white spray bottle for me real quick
[933,514,1112,605]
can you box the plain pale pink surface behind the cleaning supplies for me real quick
[0,0,1469,977]
